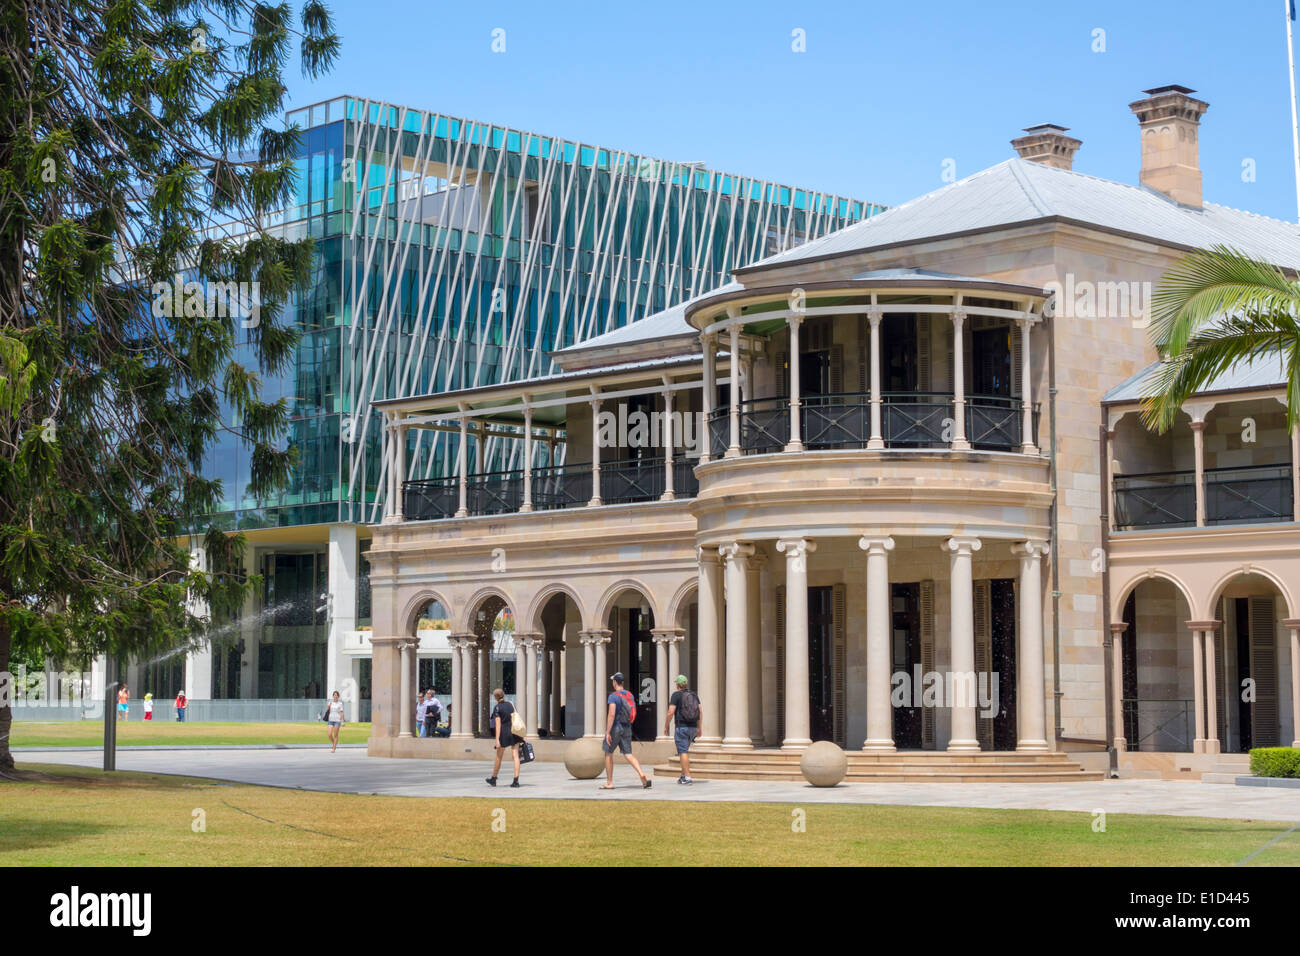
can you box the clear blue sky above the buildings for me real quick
[290,0,1296,221]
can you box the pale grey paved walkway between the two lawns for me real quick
[18,748,1300,823]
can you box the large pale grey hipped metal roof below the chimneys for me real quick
[736,159,1300,276]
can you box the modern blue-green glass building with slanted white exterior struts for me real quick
[162,96,881,710]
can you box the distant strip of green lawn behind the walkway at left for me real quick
[9,721,371,747]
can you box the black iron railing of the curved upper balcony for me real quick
[709,392,1039,458]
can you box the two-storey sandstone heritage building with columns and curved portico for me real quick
[368,86,1300,779]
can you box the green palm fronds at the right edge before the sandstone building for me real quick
[1143,246,1300,432]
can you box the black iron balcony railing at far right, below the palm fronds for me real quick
[1114,464,1295,531]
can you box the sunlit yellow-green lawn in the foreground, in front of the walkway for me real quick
[0,763,1300,866]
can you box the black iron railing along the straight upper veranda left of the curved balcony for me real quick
[402,458,699,522]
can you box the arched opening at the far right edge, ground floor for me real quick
[1206,574,1296,753]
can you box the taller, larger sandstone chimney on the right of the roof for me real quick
[1128,86,1210,208]
